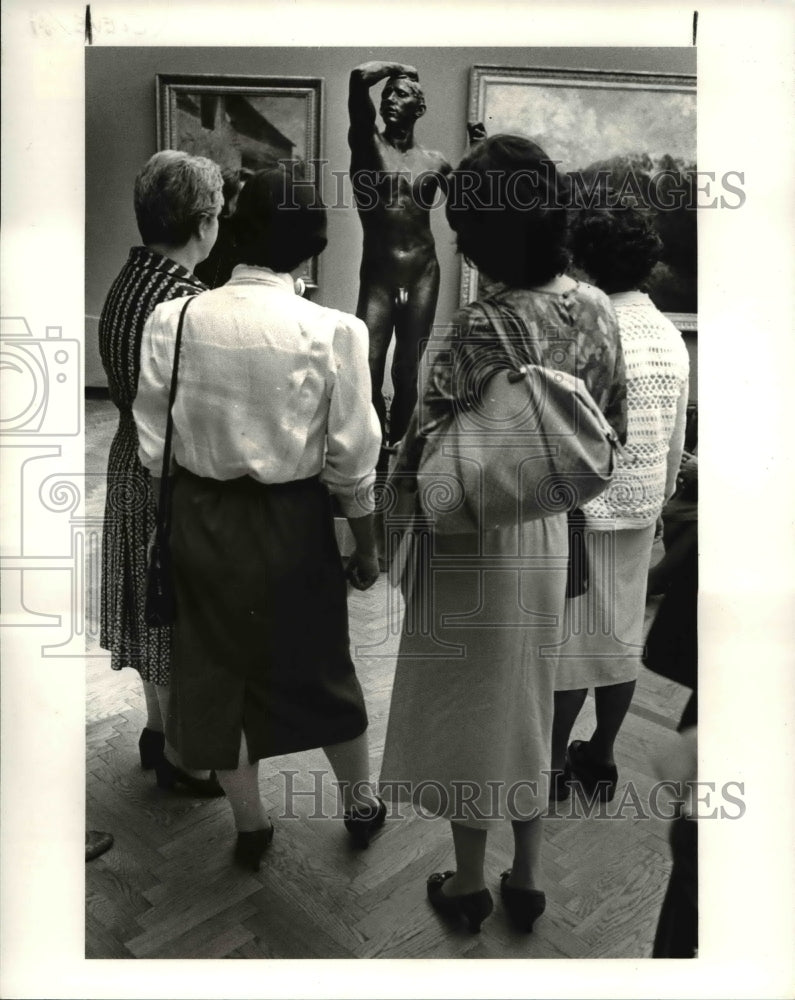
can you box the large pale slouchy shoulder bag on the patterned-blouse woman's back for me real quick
[417,301,621,534]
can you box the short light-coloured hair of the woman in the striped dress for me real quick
[133,149,223,247]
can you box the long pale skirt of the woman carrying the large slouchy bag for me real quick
[381,515,568,827]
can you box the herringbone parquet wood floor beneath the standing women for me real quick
[85,400,687,959]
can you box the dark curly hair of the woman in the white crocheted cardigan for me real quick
[571,202,663,295]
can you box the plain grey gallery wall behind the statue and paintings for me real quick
[85,47,696,398]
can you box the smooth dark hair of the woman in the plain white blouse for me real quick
[232,165,328,272]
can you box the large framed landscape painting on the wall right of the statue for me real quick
[461,66,698,332]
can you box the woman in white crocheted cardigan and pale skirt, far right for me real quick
[552,199,689,801]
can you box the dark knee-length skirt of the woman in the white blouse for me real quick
[167,469,367,768]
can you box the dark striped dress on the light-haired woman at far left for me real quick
[99,246,205,685]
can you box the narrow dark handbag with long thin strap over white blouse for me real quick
[144,299,192,627]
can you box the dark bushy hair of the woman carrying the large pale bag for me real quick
[446,135,569,288]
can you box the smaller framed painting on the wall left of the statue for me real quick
[157,73,323,288]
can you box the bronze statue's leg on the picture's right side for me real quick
[389,260,439,443]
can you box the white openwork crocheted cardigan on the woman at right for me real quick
[583,292,690,528]
